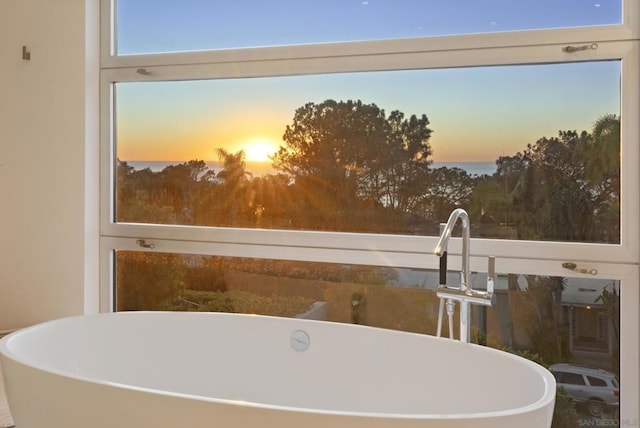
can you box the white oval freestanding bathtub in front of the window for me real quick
[0,312,556,428]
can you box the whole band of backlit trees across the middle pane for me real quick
[116,100,620,243]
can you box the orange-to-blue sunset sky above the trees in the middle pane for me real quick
[116,61,620,163]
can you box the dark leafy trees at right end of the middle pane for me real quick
[504,115,620,243]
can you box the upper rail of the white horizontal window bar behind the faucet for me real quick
[103,219,637,264]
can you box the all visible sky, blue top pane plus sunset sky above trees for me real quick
[116,0,620,162]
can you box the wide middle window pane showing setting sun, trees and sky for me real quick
[115,61,620,244]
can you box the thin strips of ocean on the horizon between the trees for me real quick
[125,161,497,177]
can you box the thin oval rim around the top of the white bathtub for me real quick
[0,311,556,420]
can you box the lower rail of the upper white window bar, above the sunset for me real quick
[102,39,633,82]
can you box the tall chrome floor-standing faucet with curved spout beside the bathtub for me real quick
[433,208,495,342]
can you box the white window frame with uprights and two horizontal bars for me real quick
[100,0,640,424]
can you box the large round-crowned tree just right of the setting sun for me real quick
[273,100,431,229]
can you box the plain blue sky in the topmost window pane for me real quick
[118,0,622,54]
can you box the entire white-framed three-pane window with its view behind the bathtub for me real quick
[100,0,640,426]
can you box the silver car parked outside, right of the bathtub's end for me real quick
[549,364,620,417]
